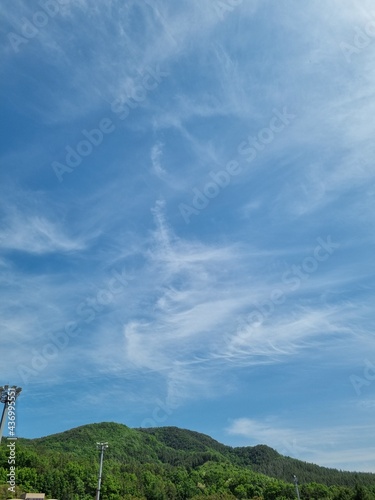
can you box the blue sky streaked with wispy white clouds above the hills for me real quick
[0,0,375,472]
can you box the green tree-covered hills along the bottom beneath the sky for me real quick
[0,423,375,500]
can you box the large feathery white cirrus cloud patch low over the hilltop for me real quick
[81,201,367,401]
